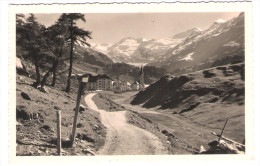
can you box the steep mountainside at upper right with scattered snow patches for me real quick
[149,13,245,73]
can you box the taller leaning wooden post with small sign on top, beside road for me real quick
[70,77,82,147]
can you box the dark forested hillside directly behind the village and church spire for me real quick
[73,46,166,84]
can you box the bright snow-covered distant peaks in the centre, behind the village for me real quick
[101,28,205,64]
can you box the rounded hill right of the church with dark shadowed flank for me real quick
[131,63,245,142]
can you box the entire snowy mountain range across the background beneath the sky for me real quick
[93,13,244,70]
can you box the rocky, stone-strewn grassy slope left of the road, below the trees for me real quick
[16,75,105,155]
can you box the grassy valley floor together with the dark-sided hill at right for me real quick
[98,64,245,153]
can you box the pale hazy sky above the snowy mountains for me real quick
[27,12,239,44]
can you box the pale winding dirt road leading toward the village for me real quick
[85,93,168,155]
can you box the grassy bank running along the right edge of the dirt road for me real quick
[93,91,198,154]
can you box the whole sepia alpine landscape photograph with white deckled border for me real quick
[5,3,253,163]
